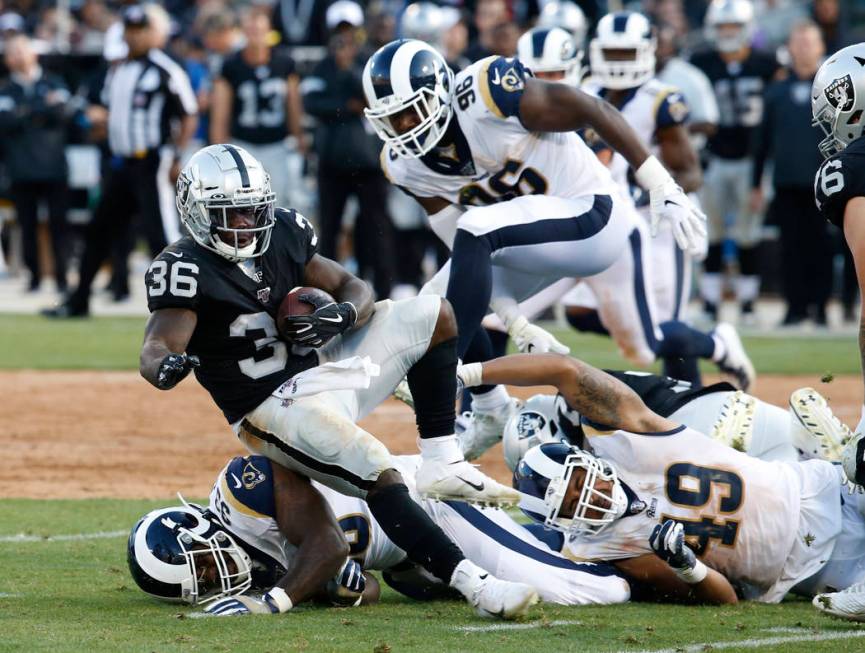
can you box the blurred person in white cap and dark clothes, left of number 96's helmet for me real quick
[303,1,395,299]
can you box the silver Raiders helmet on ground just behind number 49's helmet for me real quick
[502,394,580,471]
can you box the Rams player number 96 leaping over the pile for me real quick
[363,40,704,458]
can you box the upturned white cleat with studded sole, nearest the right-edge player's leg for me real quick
[790,388,853,463]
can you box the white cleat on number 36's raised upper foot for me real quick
[415,457,520,506]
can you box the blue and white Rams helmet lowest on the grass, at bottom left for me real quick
[126,503,252,605]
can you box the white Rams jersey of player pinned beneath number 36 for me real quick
[209,456,419,569]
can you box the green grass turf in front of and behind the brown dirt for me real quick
[0,316,865,653]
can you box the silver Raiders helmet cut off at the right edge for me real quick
[811,43,865,157]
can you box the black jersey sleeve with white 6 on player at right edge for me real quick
[814,136,865,229]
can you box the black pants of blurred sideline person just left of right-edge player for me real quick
[771,186,834,317]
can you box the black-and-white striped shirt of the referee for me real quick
[101,49,198,157]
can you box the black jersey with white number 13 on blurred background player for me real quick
[222,50,294,143]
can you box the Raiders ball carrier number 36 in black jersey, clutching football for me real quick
[140,145,537,617]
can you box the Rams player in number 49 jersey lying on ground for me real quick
[461,355,865,602]
